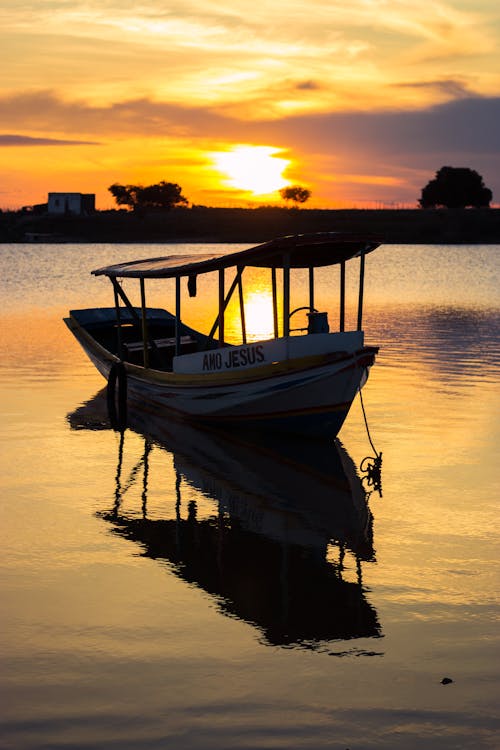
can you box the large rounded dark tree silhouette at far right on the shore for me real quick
[419,167,493,208]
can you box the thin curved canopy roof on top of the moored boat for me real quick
[92,232,380,279]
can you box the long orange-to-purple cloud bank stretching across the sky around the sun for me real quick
[0,90,500,202]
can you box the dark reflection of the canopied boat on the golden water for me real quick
[69,393,381,653]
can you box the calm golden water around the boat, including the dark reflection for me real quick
[0,245,500,750]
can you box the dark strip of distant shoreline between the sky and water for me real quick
[0,207,500,244]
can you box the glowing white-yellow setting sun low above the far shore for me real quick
[212,145,290,195]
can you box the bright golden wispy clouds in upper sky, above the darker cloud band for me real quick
[0,0,500,112]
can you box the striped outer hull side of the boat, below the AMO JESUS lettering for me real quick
[66,319,377,439]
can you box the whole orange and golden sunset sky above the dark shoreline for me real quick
[0,0,500,210]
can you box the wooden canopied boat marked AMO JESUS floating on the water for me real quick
[65,232,380,440]
